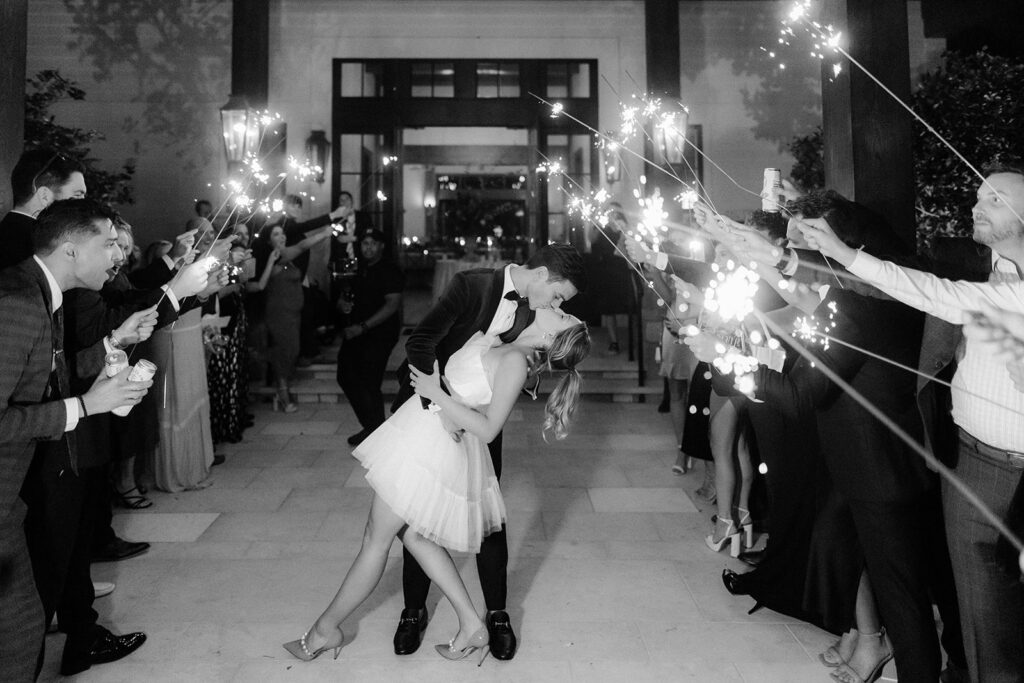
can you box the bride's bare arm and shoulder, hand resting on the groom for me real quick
[410,352,526,443]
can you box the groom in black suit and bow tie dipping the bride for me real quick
[391,244,586,659]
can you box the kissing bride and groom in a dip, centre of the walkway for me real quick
[285,244,590,663]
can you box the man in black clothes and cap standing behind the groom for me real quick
[337,228,406,445]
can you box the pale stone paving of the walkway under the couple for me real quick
[41,400,891,683]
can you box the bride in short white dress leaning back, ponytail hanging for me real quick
[285,308,590,663]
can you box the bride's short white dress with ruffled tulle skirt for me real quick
[352,333,505,553]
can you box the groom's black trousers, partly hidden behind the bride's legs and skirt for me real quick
[401,432,509,611]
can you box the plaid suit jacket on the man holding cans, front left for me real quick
[0,258,68,525]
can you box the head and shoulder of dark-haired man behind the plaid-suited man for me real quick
[0,148,85,268]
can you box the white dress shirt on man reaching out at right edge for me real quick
[848,251,1024,452]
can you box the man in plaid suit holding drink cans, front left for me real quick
[0,200,152,681]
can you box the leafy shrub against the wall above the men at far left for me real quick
[25,70,135,205]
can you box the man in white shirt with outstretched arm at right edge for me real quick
[801,165,1024,683]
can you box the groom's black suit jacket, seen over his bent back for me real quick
[391,268,505,411]
